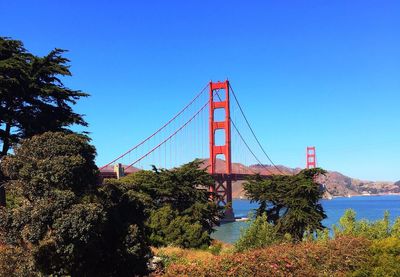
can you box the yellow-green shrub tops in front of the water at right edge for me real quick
[333,209,392,240]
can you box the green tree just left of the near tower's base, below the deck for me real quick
[107,160,222,248]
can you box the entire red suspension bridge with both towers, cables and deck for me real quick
[100,80,316,221]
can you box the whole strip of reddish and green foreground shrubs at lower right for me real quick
[156,210,400,277]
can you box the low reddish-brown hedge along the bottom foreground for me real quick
[165,236,370,277]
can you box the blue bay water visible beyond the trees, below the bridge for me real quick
[212,195,400,243]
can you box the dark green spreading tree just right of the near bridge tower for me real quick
[244,168,326,241]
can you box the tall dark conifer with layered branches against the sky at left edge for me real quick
[0,37,88,206]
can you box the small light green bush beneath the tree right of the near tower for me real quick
[235,213,283,252]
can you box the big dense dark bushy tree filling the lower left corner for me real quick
[0,132,150,276]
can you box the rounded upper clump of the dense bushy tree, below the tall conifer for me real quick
[2,132,98,198]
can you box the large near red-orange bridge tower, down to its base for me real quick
[209,80,234,221]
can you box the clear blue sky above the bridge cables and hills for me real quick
[0,0,400,181]
